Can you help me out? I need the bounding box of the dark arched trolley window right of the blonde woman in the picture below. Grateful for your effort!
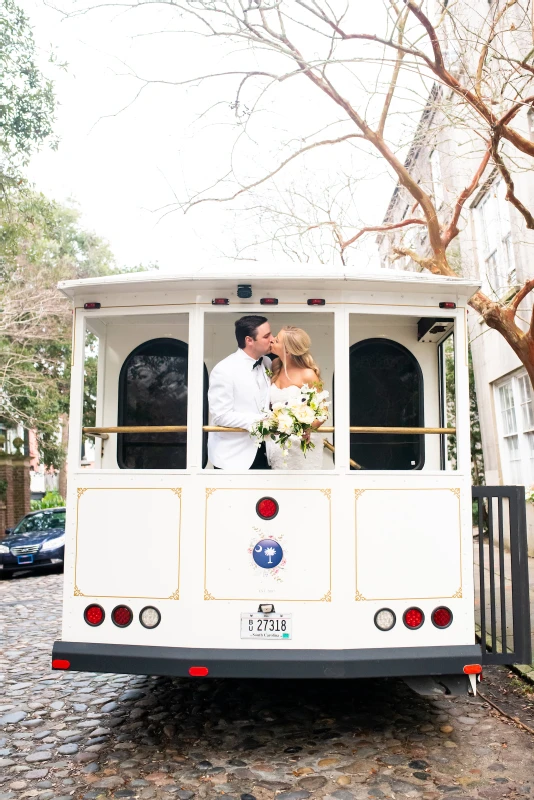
[350,338,425,470]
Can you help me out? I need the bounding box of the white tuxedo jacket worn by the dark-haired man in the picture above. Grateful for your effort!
[208,349,271,470]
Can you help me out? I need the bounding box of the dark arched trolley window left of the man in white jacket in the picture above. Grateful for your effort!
[117,338,208,469]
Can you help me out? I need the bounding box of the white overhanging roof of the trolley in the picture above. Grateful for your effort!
[58,261,480,298]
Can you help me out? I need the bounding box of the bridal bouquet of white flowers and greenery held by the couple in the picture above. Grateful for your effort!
[250,384,330,455]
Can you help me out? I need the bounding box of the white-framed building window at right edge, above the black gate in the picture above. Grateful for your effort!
[497,372,534,486]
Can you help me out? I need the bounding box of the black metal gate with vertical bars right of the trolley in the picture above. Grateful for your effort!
[473,486,532,664]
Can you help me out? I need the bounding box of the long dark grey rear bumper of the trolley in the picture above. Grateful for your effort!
[52,641,482,678]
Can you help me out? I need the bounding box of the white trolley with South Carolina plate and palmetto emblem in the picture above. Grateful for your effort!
[53,263,528,691]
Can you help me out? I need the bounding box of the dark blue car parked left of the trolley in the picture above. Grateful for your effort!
[0,508,66,577]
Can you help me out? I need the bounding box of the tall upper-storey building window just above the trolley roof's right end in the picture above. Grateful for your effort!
[475,178,516,297]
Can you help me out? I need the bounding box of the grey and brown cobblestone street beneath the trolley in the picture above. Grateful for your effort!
[0,575,534,800]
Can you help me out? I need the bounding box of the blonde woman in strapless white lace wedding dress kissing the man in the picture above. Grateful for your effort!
[266,325,323,469]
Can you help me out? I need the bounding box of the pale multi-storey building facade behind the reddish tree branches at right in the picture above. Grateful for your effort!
[377,0,534,555]
